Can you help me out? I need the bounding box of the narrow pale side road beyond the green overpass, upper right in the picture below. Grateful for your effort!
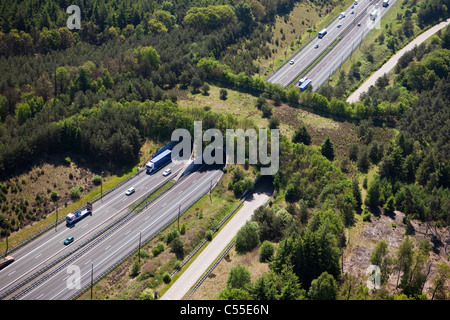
[347,19,450,102]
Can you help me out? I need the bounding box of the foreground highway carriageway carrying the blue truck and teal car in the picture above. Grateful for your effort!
[0,159,182,295]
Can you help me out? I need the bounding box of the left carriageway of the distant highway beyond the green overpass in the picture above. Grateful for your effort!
[266,0,374,86]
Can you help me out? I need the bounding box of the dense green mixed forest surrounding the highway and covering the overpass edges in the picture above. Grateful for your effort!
[0,0,450,299]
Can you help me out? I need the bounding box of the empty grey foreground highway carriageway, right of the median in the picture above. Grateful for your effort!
[16,166,223,300]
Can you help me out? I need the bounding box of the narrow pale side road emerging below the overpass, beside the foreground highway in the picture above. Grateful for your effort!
[161,182,273,300]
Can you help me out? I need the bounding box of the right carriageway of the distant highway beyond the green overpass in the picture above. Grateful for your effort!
[305,0,395,91]
